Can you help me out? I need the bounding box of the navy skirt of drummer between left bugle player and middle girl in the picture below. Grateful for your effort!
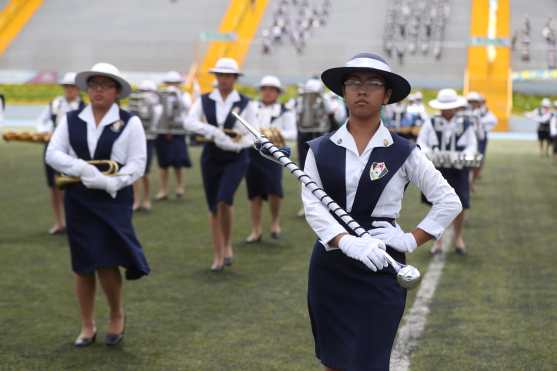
[155,134,192,169]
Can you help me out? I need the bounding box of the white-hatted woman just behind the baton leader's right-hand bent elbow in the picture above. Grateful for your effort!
[417,89,478,255]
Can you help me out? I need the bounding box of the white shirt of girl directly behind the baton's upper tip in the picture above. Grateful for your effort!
[250,101,298,140]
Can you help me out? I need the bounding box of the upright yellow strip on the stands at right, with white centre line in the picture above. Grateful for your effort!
[464,0,512,131]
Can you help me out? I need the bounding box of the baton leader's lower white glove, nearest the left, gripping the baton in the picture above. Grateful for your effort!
[338,235,388,272]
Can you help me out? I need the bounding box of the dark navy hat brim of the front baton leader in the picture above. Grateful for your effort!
[321,67,411,104]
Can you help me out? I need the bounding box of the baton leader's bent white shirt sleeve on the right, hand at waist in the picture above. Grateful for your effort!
[403,148,462,239]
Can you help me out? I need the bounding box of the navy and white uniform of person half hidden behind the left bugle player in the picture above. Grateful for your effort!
[36,96,85,188]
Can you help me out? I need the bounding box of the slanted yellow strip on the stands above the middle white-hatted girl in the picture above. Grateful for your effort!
[197,0,268,93]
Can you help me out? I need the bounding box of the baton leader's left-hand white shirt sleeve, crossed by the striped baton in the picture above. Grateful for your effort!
[302,149,347,244]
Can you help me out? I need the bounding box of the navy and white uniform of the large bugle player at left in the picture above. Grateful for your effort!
[46,104,150,279]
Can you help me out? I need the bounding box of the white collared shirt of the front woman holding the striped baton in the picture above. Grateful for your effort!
[302,123,462,245]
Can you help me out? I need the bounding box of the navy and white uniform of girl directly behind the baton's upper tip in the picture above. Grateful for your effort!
[246,102,297,200]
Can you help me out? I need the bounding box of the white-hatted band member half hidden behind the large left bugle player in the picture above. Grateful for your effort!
[37,72,85,235]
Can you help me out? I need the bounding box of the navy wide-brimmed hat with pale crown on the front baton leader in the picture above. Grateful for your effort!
[321,53,411,104]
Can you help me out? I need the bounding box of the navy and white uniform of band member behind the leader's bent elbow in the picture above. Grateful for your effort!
[417,113,478,209]
